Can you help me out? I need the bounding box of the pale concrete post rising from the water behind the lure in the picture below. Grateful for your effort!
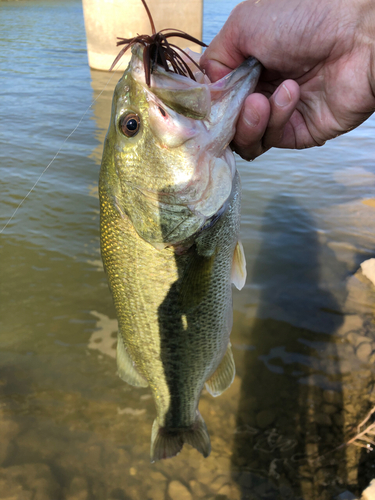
[82,0,203,71]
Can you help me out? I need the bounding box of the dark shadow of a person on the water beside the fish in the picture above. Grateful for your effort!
[232,195,347,500]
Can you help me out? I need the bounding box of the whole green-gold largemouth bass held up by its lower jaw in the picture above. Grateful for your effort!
[99,44,260,461]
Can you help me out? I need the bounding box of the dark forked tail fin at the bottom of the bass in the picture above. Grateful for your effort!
[151,412,211,462]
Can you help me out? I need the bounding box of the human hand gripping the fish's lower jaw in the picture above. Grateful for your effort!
[200,0,375,160]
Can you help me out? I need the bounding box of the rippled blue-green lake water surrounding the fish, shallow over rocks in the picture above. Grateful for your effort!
[0,0,375,500]
